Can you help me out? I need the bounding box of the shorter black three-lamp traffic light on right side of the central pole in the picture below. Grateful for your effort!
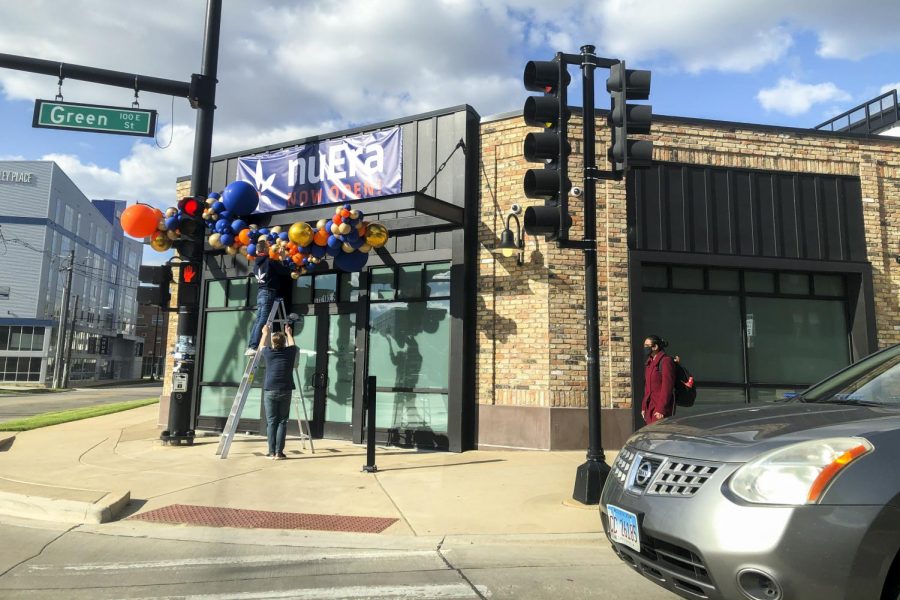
[606,61,653,173]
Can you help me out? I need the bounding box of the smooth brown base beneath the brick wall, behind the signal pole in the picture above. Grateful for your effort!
[477,404,633,450]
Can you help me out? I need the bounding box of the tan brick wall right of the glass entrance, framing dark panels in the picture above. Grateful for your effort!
[477,111,900,436]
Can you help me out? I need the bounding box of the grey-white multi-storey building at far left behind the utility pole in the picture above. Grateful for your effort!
[0,161,143,383]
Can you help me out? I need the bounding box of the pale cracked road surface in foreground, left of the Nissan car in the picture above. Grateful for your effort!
[0,521,675,600]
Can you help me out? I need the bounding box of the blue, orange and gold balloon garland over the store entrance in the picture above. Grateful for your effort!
[119,181,388,279]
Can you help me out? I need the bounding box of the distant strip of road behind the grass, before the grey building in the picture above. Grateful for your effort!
[0,382,162,423]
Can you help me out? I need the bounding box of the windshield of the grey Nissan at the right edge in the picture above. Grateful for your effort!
[797,346,900,408]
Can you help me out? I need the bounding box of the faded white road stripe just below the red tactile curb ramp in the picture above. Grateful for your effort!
[28,550,439,572]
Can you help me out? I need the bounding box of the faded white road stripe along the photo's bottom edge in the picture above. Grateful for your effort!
[125,583,491,600]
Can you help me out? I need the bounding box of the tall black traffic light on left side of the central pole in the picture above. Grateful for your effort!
[523,54,572,241]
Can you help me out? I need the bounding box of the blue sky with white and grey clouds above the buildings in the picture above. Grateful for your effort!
[0,0,900,264]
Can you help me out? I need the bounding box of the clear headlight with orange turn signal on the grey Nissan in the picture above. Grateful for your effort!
[728,437,873,505]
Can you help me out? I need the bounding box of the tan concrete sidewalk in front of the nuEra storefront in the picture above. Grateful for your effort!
[0,405,615,536]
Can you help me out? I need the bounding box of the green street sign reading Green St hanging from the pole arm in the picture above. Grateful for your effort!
[31,100,156,137]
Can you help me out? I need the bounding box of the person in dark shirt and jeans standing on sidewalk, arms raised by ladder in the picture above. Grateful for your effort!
[260,324,298,460]
